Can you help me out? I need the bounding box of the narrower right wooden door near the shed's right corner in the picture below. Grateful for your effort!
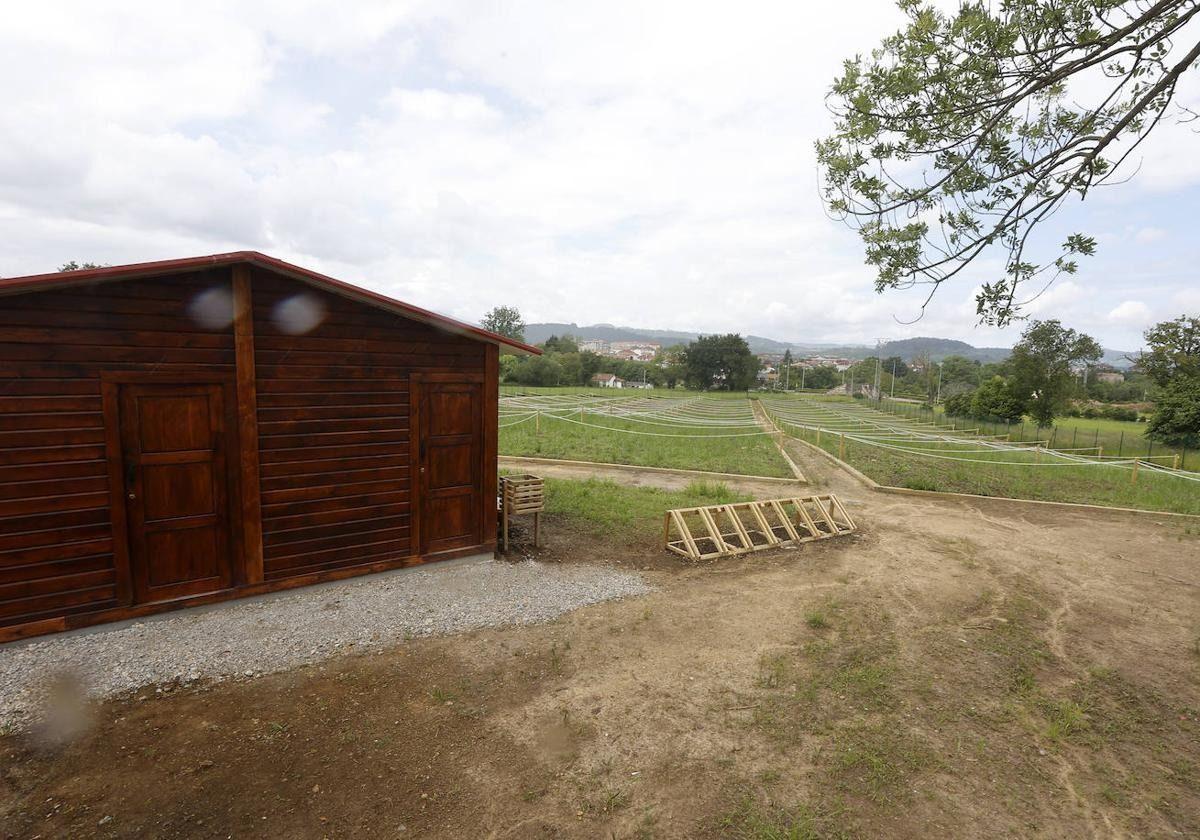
[418,380,484,554]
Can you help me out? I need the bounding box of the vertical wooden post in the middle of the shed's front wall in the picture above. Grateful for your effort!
[233,264,264,584]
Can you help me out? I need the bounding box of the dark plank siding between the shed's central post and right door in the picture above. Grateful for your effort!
[252,271,484,581]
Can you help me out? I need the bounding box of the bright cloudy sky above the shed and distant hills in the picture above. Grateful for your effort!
[0,0,1200,350]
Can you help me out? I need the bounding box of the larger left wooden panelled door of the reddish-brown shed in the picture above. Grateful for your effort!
[120,383,233,604]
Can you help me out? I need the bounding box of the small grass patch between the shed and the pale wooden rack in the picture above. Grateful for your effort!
[546,479,750,539]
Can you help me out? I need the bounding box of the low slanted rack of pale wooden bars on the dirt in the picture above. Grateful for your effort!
[662,493,856,560]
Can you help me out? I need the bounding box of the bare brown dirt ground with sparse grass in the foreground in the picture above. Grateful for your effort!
[0,451,1200,839]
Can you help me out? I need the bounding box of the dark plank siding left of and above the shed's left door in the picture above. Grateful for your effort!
[0,270,234,625]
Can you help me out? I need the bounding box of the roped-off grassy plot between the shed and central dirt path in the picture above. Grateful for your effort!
[500,389,791,478]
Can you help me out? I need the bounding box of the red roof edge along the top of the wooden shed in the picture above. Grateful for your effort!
[0,251,541,355]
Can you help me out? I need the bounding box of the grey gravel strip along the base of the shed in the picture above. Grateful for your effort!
[0,560,650,728]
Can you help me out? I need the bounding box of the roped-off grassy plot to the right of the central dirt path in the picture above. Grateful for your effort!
[773,401,1200,515]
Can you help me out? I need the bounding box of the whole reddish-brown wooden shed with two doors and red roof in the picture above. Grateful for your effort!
[0,252,538,641]
